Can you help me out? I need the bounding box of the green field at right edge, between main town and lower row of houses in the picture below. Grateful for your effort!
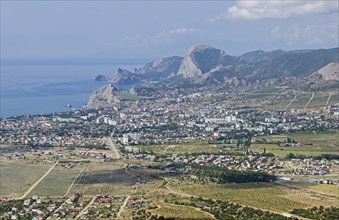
[252,131,339,158]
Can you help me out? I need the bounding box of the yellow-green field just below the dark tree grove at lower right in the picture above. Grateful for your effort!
[181,183,307,212]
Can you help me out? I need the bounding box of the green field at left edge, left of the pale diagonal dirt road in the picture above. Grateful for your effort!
[0,161,52,197]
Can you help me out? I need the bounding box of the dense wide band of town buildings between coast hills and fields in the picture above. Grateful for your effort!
[0,102,339,147]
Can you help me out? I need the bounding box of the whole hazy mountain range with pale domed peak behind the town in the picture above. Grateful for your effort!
[89,45,339,108]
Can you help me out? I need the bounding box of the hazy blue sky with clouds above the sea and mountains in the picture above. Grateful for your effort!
[0,0,339,62]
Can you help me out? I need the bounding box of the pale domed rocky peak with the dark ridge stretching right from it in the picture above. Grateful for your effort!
[176,45,339,86]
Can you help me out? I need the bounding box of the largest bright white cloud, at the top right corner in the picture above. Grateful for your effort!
[208,0,339,22]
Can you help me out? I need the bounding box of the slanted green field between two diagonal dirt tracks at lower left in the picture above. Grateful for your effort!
[29,164,85,196]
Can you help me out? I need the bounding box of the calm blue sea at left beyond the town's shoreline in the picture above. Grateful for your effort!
[0,64,141,117]
